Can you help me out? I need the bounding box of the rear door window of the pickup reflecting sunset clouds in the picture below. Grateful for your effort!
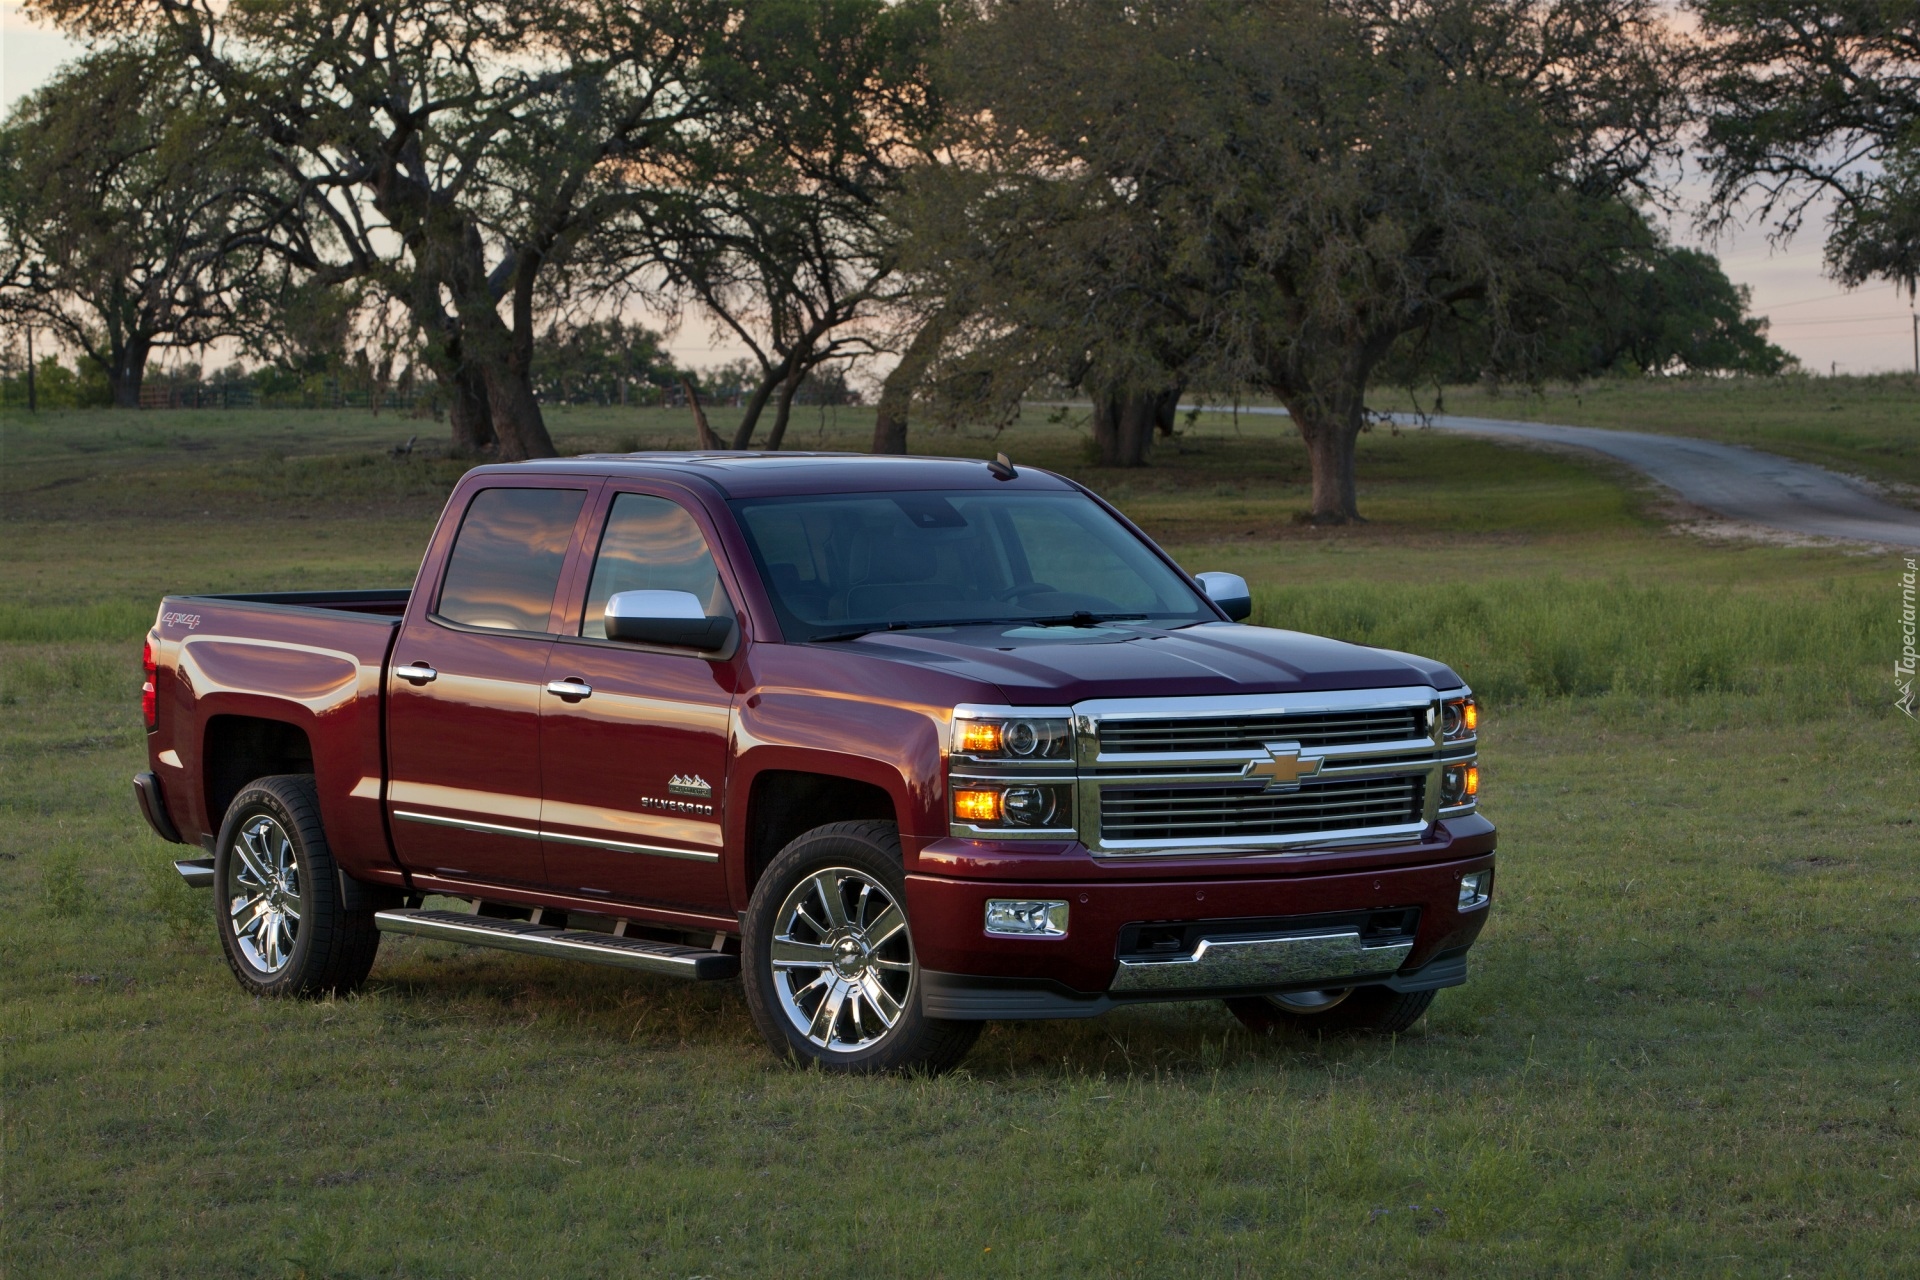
[434,489,588,631]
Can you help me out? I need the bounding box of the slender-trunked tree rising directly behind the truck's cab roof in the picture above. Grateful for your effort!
[605,0,939,449]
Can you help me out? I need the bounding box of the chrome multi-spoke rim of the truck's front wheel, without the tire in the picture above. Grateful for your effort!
[768,867,914,1054]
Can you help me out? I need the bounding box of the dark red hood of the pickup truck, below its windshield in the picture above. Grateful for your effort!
[835,622,1461,706]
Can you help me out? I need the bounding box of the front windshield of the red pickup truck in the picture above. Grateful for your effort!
[733,489,1215,641]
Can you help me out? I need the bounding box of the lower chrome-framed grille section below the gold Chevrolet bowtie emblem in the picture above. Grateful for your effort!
[1100,773,1427,841]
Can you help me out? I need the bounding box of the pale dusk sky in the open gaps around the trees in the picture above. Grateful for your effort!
[0,0,1920,374]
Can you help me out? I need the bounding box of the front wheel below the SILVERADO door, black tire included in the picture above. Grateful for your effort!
[741,821,979,1075]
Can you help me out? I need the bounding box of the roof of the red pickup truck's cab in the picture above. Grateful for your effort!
[480,451,1073,497]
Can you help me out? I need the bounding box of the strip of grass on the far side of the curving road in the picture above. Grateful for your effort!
[1377,374,1920,505]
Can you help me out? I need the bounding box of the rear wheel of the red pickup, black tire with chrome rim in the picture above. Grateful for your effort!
[213,773,380,996]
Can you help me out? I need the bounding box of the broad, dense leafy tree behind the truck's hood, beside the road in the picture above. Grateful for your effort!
[898,0,1676,522]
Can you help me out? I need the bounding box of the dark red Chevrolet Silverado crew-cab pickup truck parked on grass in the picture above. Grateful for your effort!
[134,453,1494,1071]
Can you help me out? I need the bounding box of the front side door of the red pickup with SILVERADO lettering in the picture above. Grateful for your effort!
[540,493,735,912]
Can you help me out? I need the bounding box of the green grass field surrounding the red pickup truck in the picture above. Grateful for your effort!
[0,397,1920,1276]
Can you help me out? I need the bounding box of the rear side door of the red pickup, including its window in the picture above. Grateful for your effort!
[388,476,599,885]
